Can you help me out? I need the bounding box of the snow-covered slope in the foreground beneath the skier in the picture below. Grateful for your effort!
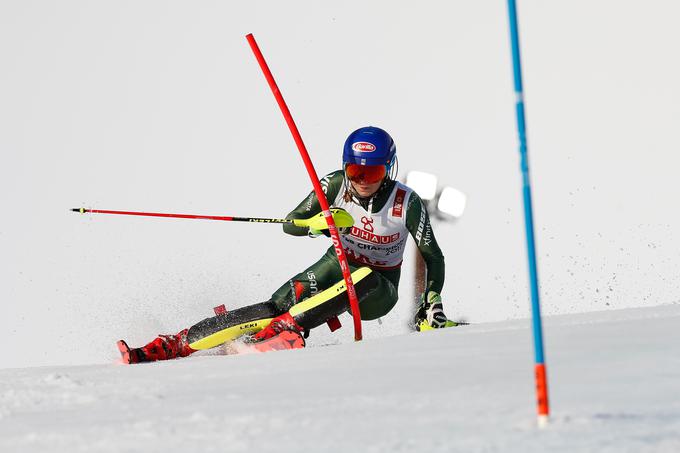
[0,305,680,453]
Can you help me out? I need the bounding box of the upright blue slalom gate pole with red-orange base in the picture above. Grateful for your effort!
[508,0,549,426]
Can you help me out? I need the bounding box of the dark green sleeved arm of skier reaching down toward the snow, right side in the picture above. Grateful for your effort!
[406,192,444,293]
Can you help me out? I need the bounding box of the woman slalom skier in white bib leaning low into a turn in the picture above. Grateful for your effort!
[118,127,456,363]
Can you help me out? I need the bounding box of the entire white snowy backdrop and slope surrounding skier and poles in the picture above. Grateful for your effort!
[0,0,680,452]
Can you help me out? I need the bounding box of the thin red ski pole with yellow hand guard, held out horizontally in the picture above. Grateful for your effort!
[71,208,354,230]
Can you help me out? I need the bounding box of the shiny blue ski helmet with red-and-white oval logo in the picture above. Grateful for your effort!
[342,126,397,167]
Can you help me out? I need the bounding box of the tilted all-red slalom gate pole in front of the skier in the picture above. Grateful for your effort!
[246,33,361,341]
